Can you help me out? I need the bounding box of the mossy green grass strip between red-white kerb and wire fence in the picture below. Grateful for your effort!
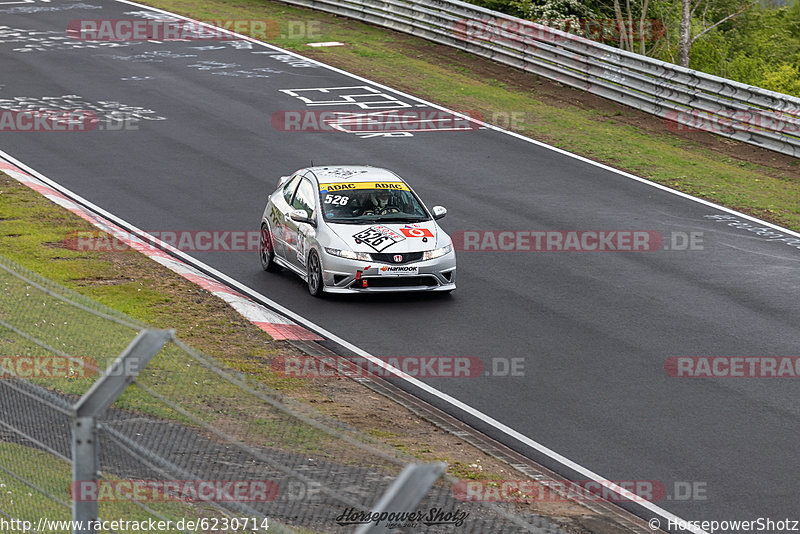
[0,173,300,391]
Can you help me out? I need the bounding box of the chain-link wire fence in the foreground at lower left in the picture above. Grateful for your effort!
[0,258,558,534]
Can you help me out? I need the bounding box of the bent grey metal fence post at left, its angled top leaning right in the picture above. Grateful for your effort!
[72,330,175,534]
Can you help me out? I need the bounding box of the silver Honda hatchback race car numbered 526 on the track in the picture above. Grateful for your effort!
[259,165,456,296]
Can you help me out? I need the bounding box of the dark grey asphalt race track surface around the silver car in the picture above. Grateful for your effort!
[0,0,800,520]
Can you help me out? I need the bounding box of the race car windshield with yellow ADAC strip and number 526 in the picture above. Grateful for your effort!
[319,182,430,224]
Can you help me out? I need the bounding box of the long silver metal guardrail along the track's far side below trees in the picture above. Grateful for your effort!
[281,0,800,157]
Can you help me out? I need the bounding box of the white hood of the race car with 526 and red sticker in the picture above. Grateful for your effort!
[328,220,442,253]
